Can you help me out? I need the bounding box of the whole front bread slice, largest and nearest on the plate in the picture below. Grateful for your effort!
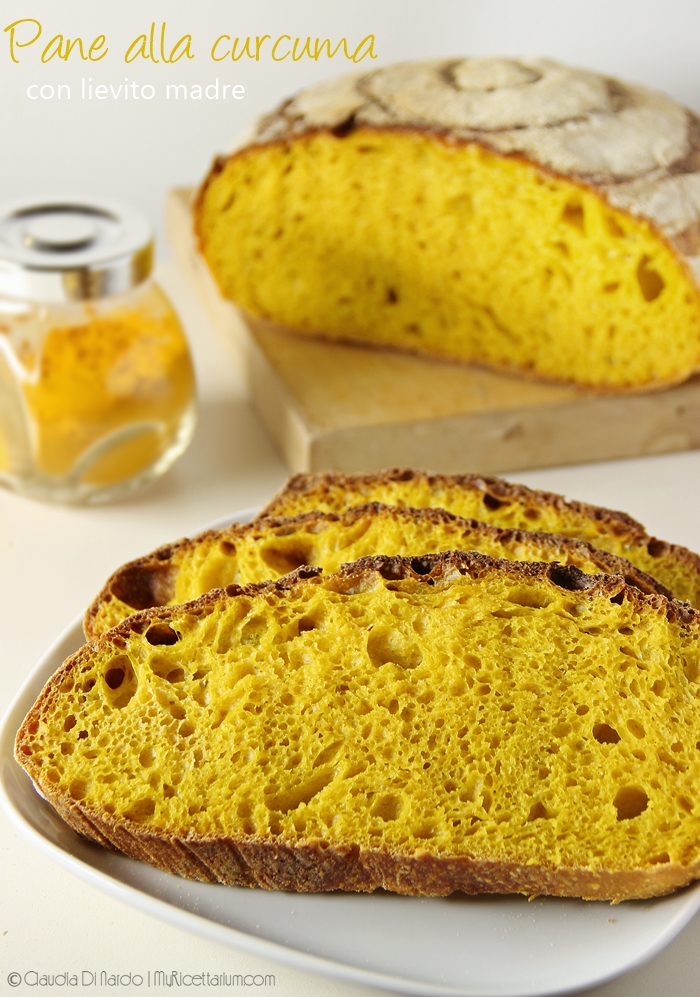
[16,552,700,900]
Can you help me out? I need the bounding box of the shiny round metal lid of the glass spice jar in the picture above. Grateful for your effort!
[0,197,153,302]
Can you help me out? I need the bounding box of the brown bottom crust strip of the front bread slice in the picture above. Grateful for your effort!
[15,794,700,903]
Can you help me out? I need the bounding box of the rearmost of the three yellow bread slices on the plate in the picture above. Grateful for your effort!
[261,468,700,608]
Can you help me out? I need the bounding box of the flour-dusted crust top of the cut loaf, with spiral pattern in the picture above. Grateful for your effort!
[242,56,700,275]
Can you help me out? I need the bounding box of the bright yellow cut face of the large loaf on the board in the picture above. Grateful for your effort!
[197,134,700,389]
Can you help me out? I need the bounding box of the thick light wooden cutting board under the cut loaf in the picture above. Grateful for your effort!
[168,189,700,473]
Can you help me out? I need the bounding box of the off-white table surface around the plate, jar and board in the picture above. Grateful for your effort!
[0,264,700,997]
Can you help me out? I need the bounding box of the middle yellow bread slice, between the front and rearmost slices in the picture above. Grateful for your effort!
[84,502,671,640]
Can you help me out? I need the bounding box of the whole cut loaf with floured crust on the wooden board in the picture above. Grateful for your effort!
[195,57,700,390]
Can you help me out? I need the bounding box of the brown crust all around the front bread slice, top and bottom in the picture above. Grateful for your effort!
[15,551,700,902]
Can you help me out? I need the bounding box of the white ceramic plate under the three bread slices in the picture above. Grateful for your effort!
[0,512,700,997]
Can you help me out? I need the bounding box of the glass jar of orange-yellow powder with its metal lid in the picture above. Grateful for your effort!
[0,199,196,502]
